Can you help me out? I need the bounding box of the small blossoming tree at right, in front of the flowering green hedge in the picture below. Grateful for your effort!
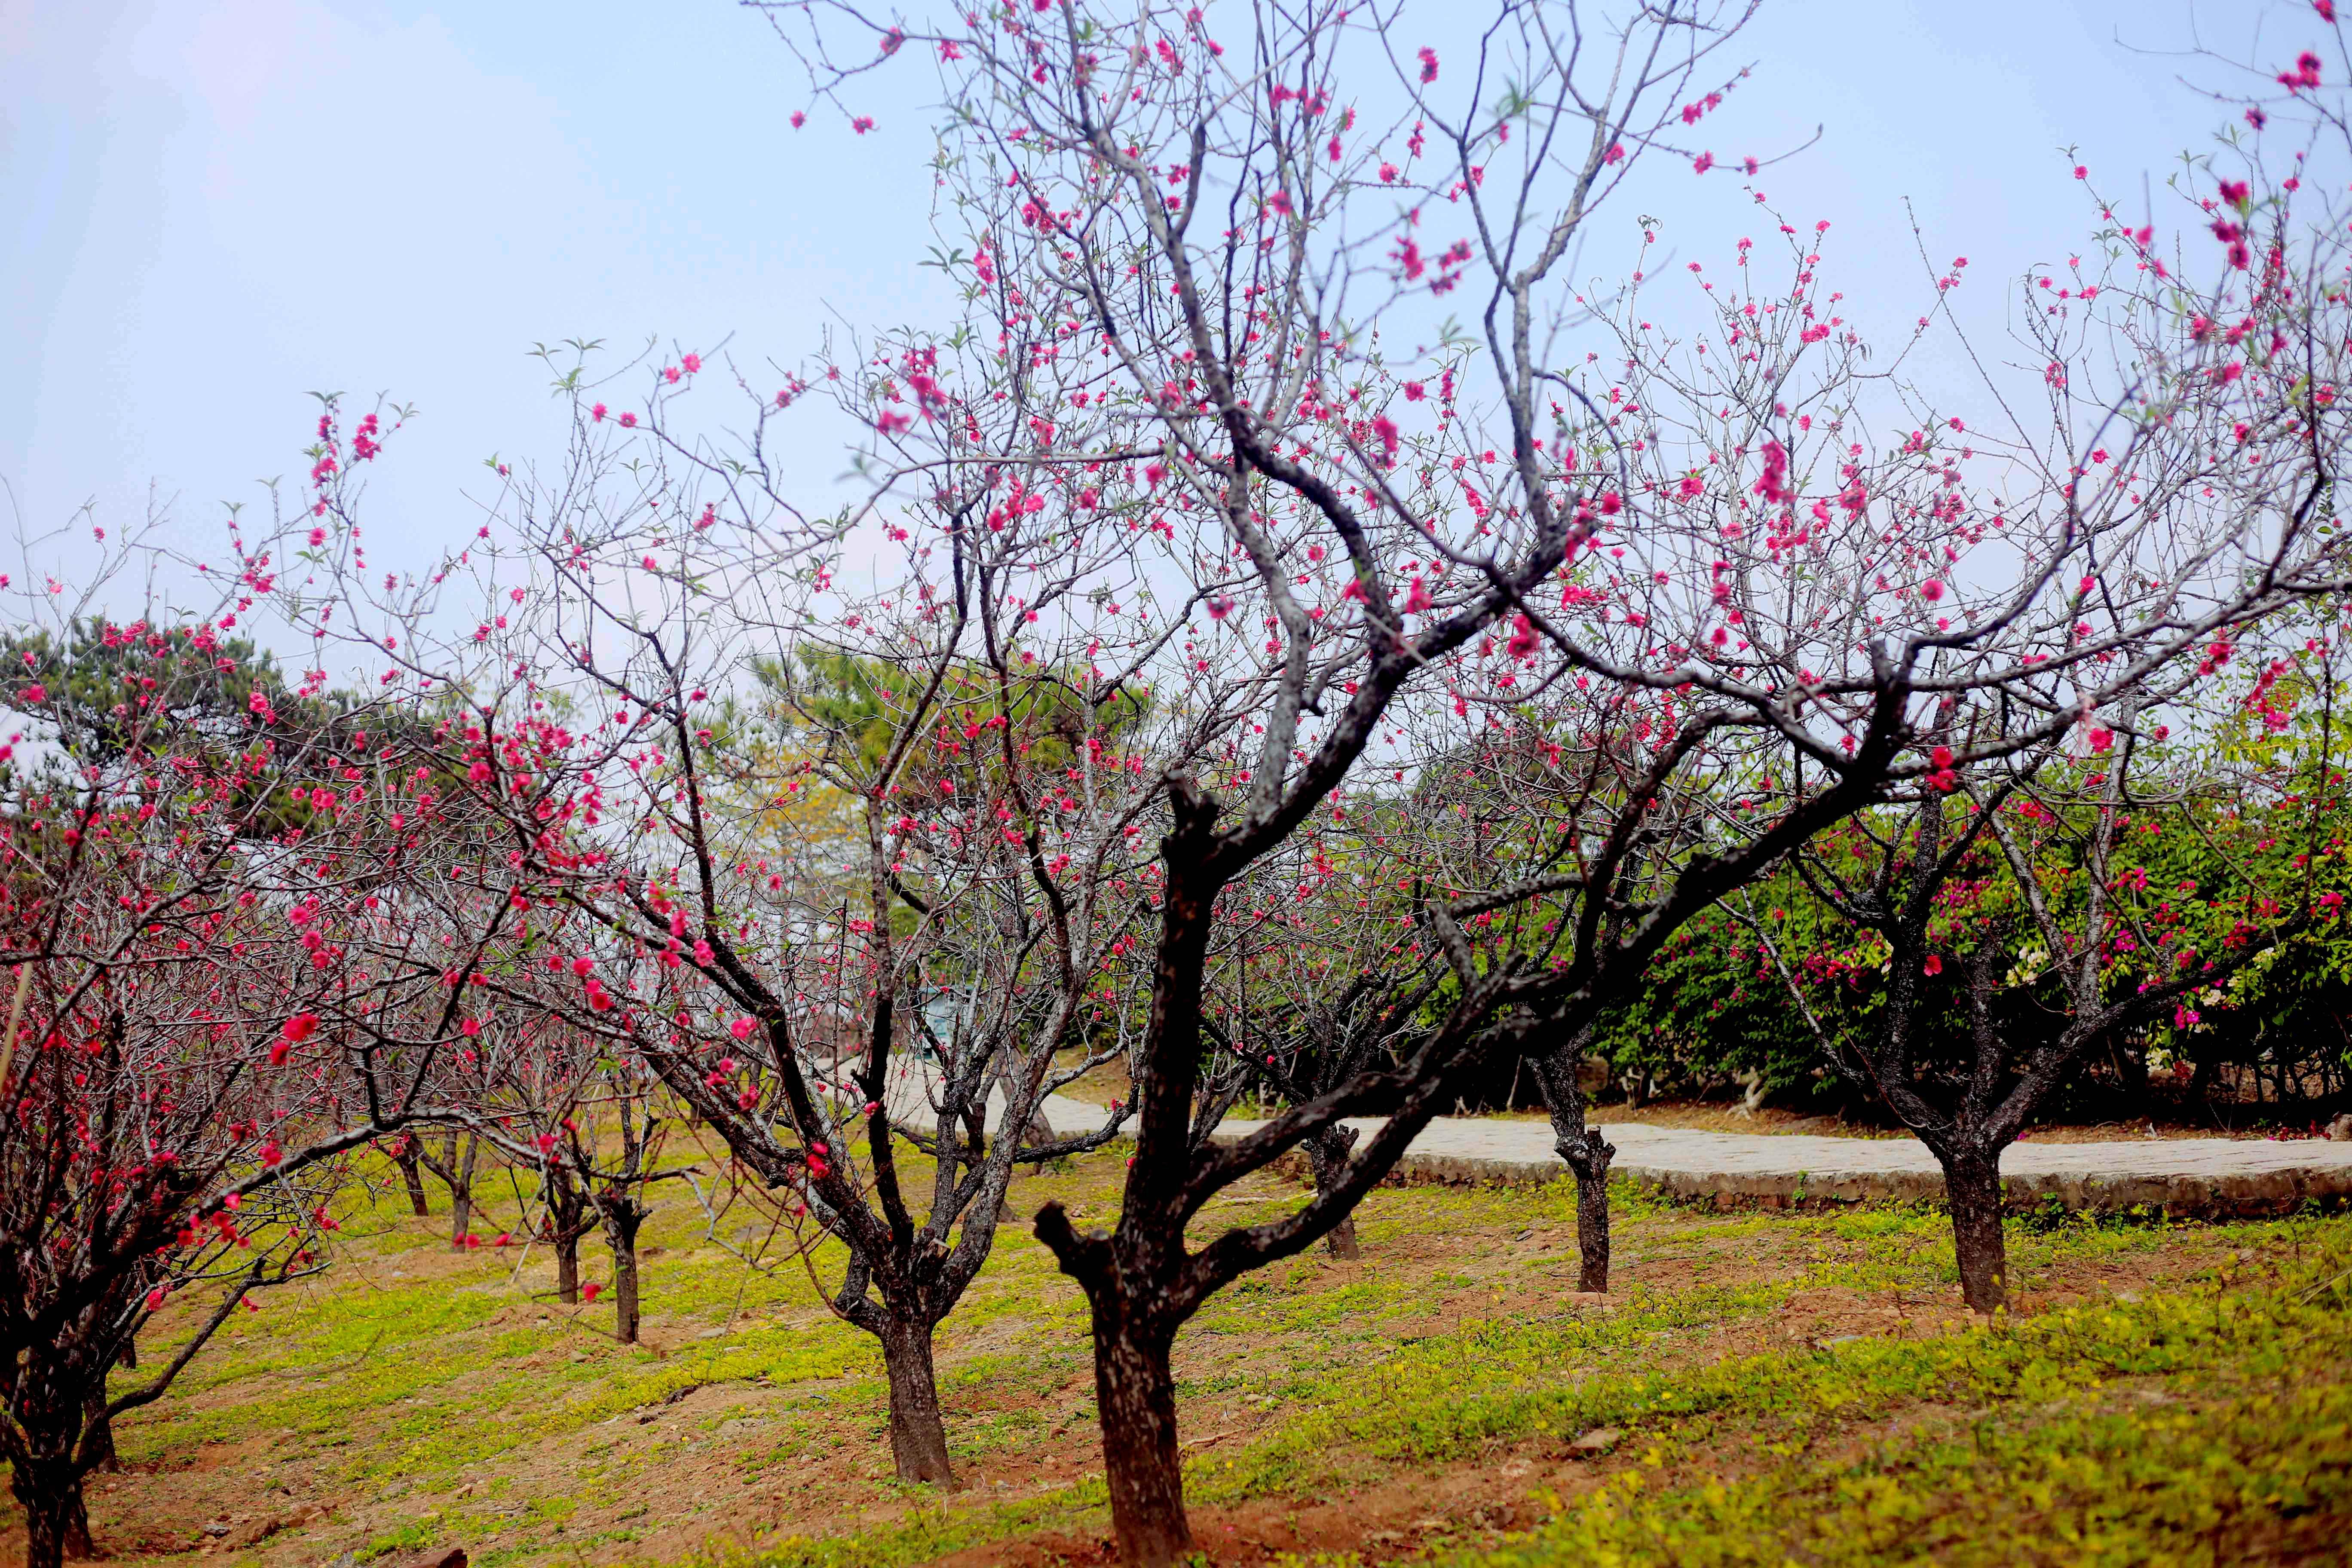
[1740,628,2345,1312]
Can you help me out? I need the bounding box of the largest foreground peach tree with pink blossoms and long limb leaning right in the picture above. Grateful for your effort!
[720,2,2343,1563]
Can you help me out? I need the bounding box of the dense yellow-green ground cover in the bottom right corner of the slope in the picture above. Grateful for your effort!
[1444,1253,2352,1568]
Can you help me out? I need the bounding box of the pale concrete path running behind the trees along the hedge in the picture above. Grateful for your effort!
[891,1077,2352,1216]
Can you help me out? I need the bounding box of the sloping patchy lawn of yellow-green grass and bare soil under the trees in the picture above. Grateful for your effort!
[0,1154,2352,1568]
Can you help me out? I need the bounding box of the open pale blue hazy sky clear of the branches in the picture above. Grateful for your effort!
[0,0,2276,588]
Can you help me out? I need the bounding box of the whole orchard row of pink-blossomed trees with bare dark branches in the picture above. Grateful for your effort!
[14,0,2352,1566]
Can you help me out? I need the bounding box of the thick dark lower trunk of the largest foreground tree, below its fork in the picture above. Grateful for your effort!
[1093,1283,1192,1568]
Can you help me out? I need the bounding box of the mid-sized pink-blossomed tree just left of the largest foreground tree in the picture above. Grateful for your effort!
[287,301,1192,1481]
